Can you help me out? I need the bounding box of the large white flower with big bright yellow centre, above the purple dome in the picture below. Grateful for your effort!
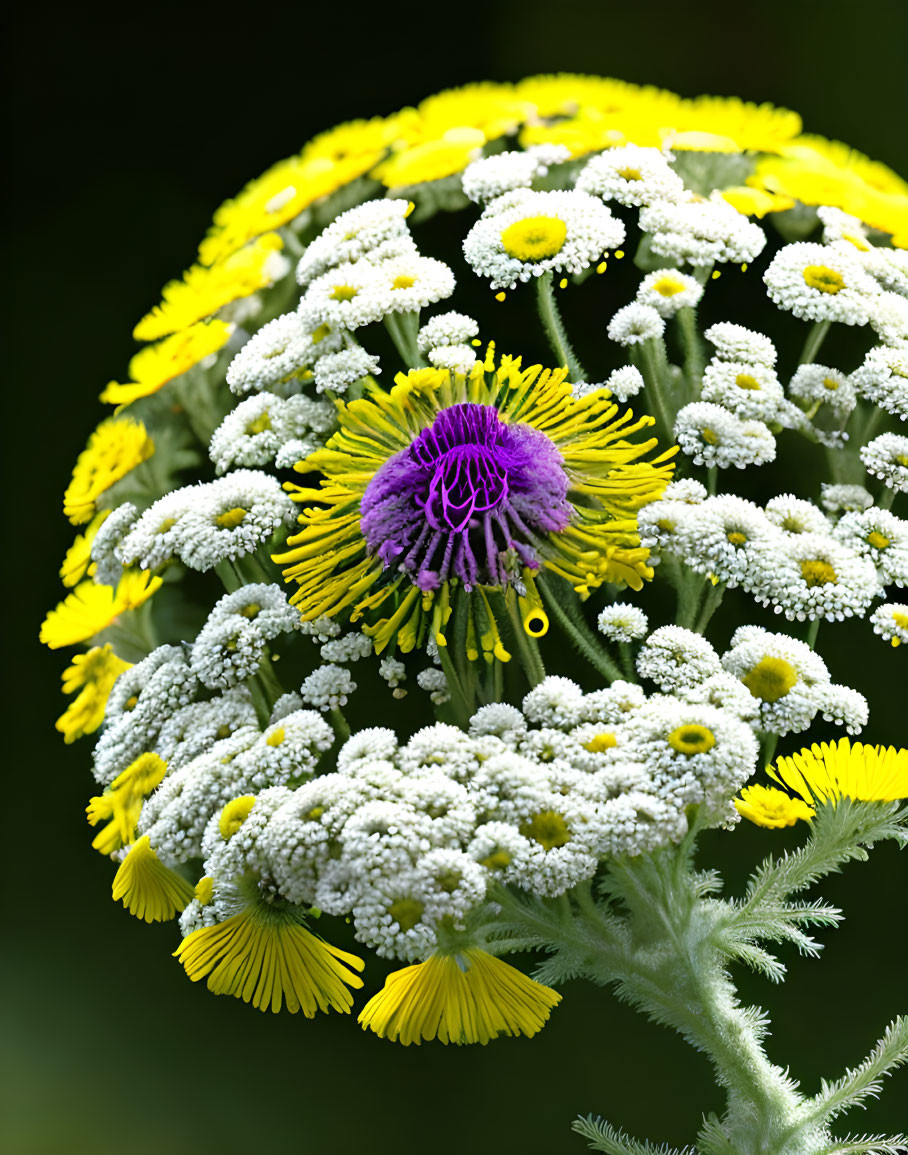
[463,189,625,289]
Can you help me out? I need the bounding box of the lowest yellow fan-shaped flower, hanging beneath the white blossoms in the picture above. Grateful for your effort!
[359,949,561,1046]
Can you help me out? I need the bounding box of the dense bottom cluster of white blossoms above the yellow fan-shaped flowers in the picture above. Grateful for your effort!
[176,677,757,960]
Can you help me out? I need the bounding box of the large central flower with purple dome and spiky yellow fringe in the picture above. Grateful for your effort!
[275,348,673,661]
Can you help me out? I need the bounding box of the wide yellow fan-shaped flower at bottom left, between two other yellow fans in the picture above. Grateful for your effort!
[173,906,363,1019]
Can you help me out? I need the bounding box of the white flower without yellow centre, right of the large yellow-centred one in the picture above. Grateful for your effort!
[640,193,766,267]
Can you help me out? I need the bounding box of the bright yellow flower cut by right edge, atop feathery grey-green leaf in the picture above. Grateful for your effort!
[767,738,908,806]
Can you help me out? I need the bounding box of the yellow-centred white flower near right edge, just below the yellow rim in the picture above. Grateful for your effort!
[764,241,879,325]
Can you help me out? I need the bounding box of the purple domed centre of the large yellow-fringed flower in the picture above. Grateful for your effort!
[362,404,572,589]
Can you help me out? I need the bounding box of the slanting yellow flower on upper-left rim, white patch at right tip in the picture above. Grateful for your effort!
[133,232,286,341]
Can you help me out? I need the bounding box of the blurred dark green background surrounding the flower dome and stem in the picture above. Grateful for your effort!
[7,0,908,1155]
